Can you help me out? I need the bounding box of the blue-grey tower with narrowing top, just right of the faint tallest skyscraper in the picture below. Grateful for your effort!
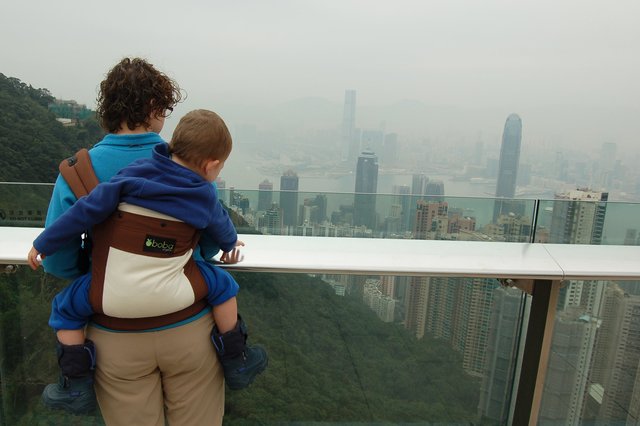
[353,151,378,229]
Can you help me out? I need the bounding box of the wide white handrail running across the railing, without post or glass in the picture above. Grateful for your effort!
[5,227,640,281]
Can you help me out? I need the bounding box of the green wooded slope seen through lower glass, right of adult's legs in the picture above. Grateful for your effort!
[225,273,480,424]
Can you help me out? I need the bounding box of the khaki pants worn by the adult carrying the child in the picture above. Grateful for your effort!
[87,314,224,426]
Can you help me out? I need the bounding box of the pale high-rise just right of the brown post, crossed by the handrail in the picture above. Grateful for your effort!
[540,189,612,425]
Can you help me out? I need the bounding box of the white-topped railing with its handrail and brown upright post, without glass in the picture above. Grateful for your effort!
[0,227,640,425]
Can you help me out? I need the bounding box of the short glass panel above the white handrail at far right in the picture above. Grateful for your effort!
[536,198,640,245]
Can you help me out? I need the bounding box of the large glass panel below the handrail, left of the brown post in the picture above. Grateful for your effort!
[0,267,526,425]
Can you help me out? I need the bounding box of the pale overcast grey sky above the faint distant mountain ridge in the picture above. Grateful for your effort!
[0,0,640,151]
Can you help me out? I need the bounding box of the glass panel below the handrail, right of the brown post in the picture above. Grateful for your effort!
[539,281,640,425]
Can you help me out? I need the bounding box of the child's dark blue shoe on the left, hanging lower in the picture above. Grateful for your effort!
[42,340,96,414]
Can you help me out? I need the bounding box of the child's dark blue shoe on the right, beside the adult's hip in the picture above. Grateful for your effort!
[211,315,268,390]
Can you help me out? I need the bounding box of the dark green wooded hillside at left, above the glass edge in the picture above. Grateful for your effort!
[0,73,102,182]
